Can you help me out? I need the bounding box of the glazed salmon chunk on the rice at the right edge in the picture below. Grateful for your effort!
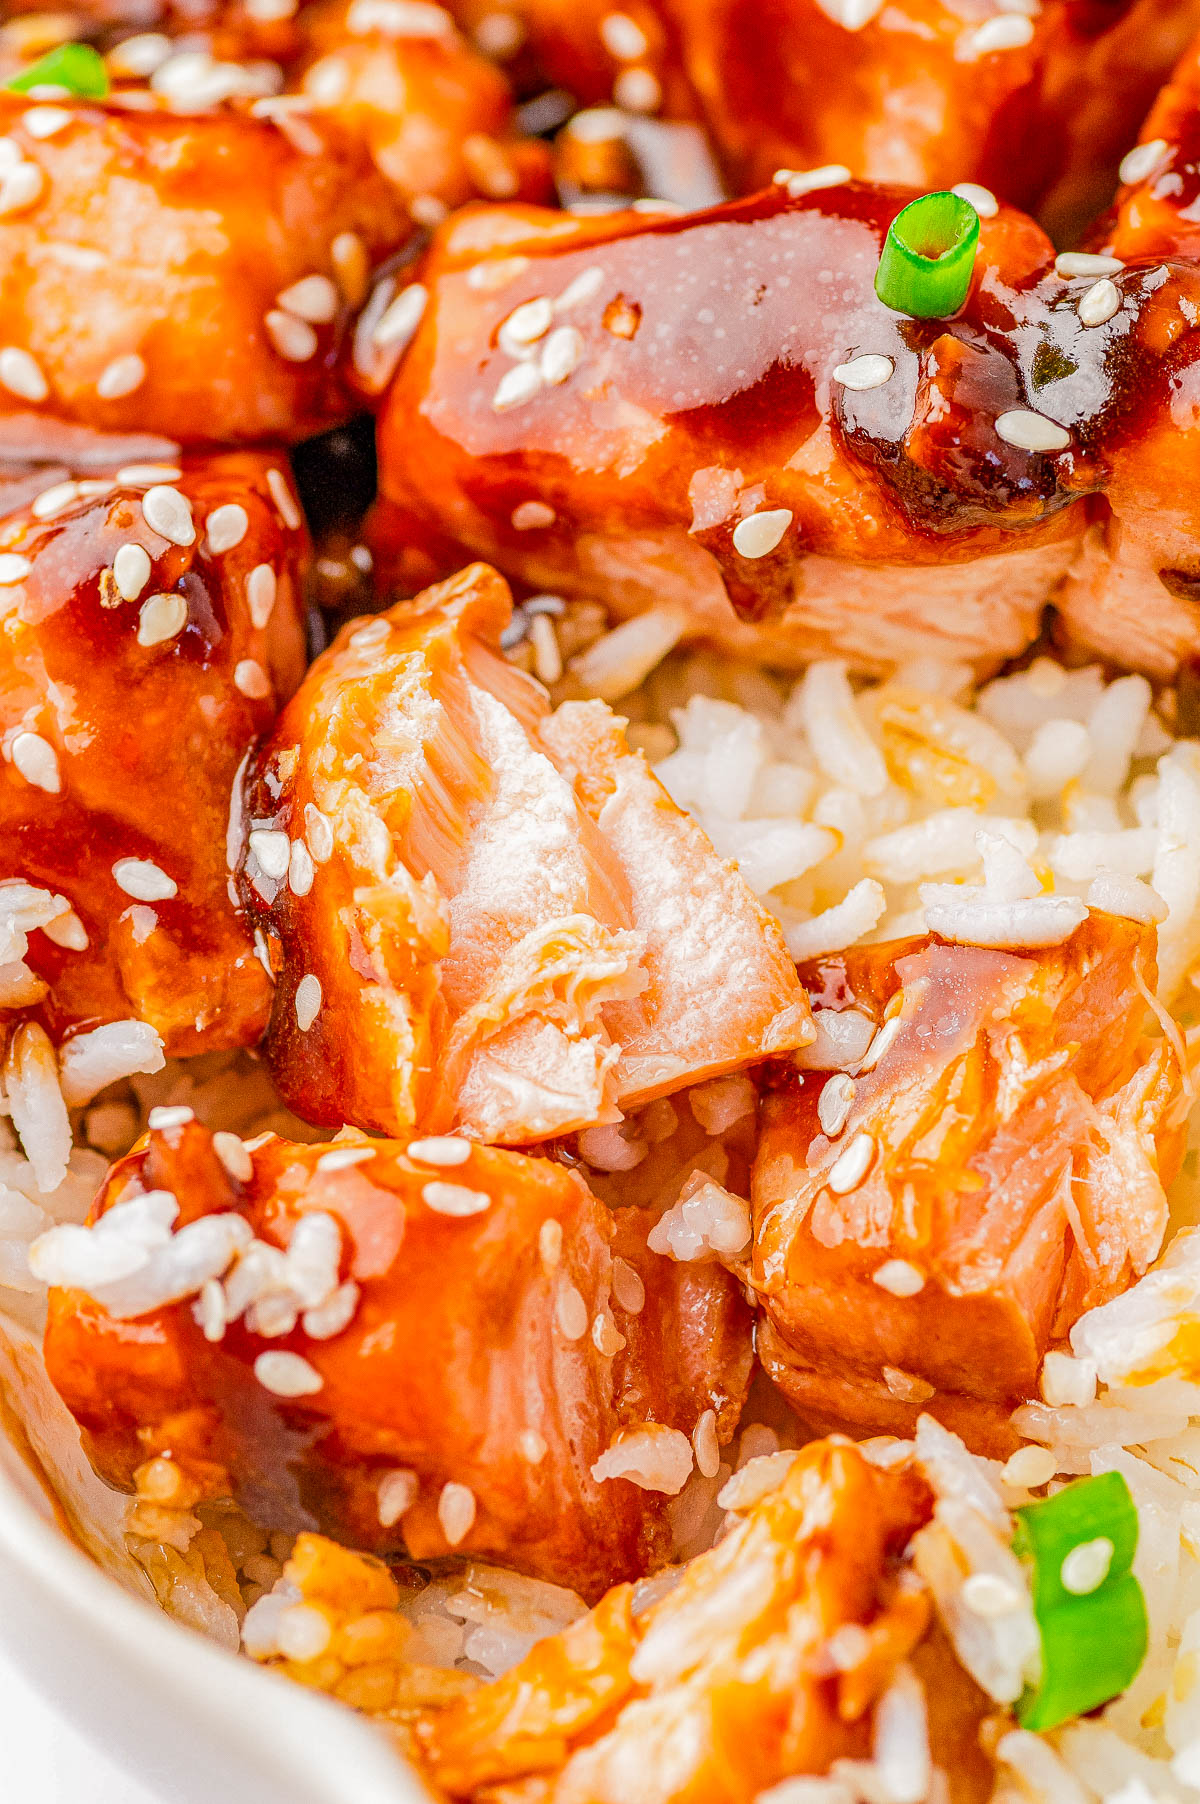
[745,911,1186,1452]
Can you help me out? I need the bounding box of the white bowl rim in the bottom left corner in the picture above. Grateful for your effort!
[0,1321,431,1804]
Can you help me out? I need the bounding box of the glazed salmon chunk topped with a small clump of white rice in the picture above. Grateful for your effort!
[44,1122,751,1598]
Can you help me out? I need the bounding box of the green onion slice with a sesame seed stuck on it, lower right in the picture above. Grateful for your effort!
[1012,1472,1148,1730]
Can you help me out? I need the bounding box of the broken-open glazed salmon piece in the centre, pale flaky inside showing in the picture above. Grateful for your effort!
[242,566,812,1142]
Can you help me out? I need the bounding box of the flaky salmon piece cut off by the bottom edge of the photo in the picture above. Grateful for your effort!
[415,1440,985,1804]
